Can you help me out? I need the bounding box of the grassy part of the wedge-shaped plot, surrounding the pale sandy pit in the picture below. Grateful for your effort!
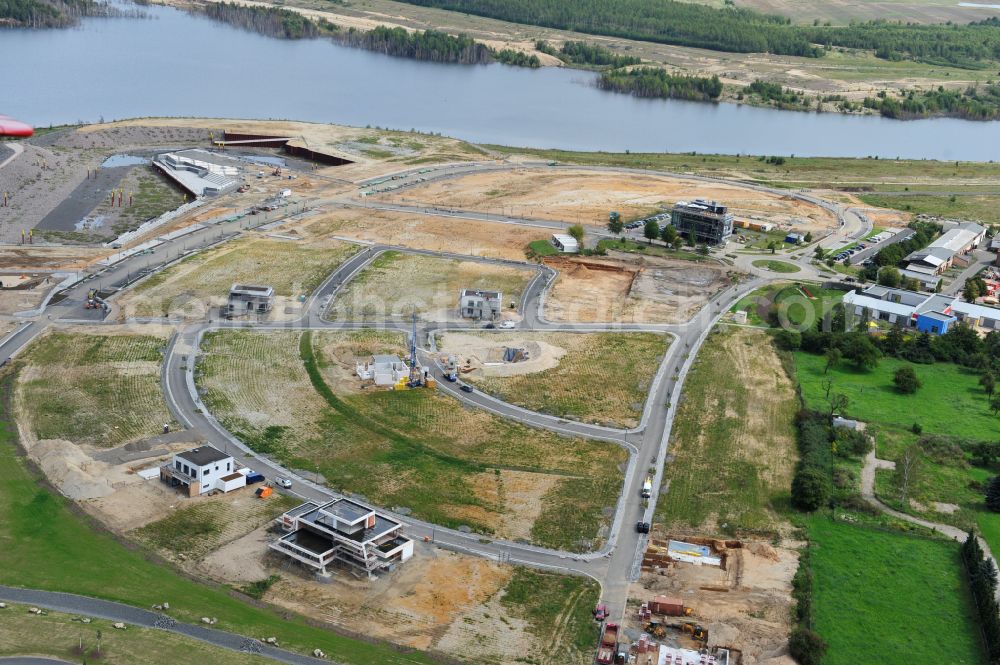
[440,333,670,427]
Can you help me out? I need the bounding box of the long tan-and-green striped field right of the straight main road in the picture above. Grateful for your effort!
[656,328,798,534]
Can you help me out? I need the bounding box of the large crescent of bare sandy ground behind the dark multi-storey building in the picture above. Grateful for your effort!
[379,169,837,231]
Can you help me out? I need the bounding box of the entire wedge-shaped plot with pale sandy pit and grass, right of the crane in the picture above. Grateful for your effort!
[438,333,671,427]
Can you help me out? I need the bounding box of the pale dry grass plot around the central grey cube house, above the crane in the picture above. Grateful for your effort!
[328,251,535,321]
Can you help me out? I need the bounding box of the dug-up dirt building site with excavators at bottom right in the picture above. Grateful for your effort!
[626,534,798,665]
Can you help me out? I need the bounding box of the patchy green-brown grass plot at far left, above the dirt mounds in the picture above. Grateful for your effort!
[17,332,172,447]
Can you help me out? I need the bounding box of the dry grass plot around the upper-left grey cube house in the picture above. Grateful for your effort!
[118,236,357,319]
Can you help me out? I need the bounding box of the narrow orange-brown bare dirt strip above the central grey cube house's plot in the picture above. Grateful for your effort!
[297,208,548,260]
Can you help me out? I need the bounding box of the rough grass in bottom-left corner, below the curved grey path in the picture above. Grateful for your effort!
[0,605,264,665]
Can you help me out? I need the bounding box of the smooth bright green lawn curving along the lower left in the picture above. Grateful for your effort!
[0,378,442,665]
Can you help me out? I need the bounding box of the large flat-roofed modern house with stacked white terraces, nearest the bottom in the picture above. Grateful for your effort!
[268,499,413,577]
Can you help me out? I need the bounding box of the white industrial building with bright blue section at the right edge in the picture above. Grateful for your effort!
[844,286,1000,335]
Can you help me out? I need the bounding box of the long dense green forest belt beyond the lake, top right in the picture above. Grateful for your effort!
[394,0,1000,68]
